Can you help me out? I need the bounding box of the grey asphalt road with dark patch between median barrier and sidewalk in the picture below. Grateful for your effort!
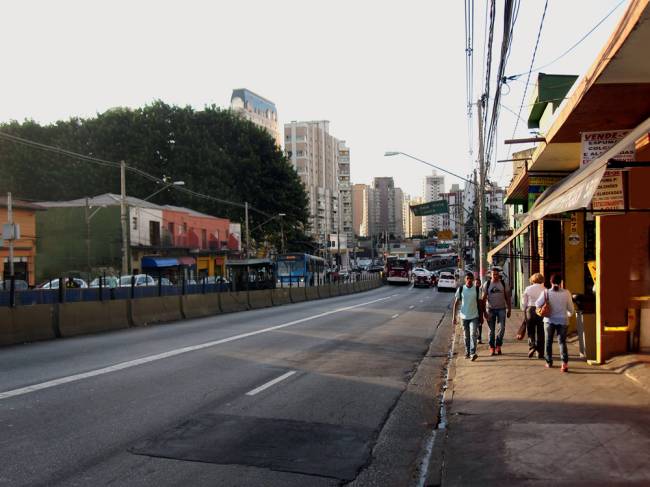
[0,286,451,486]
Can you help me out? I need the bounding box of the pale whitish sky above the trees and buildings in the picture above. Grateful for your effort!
[0,0,629,196]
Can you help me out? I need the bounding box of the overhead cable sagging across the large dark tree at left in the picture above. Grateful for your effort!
[0,132,271,218]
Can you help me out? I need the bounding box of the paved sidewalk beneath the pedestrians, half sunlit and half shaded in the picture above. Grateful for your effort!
[442,311,650,486]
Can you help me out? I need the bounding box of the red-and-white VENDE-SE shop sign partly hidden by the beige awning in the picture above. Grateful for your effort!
[582,130,635,210]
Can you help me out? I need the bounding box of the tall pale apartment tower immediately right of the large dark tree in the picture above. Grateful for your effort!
[284,120,342,244]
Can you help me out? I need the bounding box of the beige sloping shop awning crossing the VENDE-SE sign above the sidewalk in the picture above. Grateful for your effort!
[487,118,650,262]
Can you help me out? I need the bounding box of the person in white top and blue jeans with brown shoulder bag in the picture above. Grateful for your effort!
[535,274,574,372]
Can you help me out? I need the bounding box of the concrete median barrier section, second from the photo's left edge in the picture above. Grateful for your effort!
[59,299,129,337]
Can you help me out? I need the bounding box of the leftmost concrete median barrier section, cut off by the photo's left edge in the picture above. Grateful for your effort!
[0,304,56,346]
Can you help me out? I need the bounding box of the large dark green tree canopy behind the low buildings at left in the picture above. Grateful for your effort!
[0,101,309,248]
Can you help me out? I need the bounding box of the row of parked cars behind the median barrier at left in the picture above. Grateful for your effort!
[0,274,228,291]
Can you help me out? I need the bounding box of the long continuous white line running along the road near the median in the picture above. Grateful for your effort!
[0,294,396,400]
